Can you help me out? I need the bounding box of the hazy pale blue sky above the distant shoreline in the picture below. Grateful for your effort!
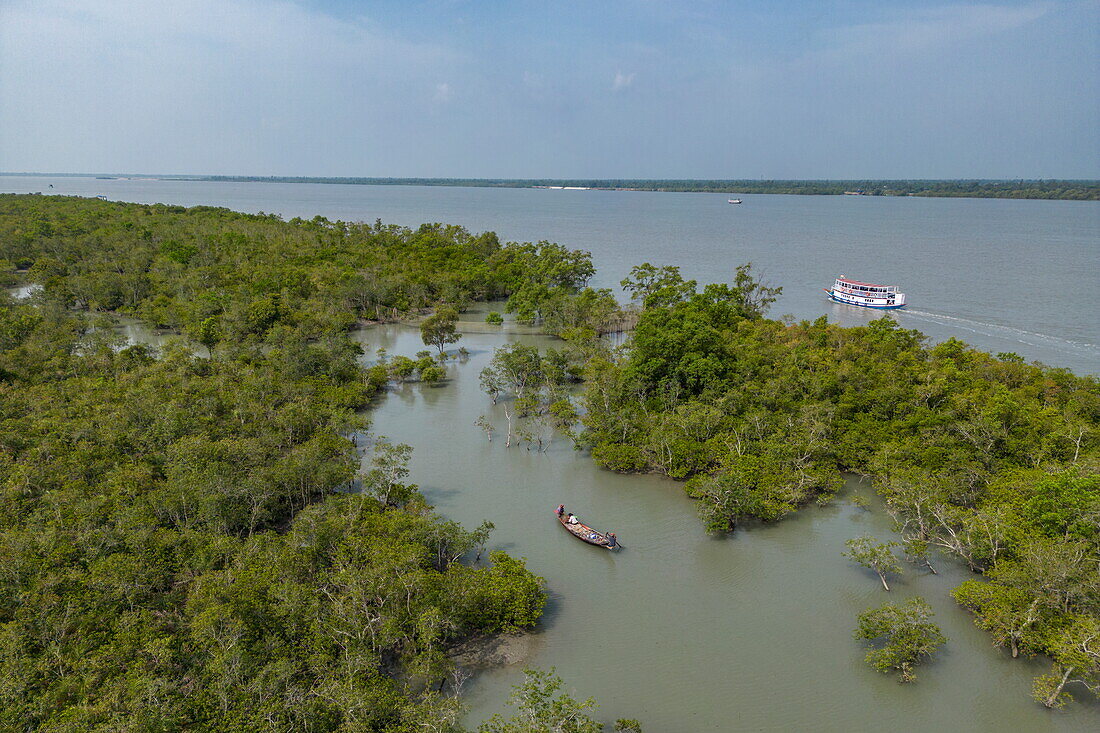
[0,0,1100,178]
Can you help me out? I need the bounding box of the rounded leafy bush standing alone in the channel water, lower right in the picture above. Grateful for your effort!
[855,598,947,682]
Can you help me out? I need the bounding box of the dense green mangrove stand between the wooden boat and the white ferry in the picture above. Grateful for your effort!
[583,260,1100,704]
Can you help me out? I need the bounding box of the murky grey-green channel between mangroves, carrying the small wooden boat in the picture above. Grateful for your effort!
[358,314,1100,733]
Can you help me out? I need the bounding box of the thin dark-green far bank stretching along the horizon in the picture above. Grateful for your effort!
[0,173,1100,201]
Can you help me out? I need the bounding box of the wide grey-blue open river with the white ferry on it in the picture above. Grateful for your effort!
[0,176,1100,373]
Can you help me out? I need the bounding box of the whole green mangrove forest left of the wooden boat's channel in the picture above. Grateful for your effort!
[0,192,567,731]
